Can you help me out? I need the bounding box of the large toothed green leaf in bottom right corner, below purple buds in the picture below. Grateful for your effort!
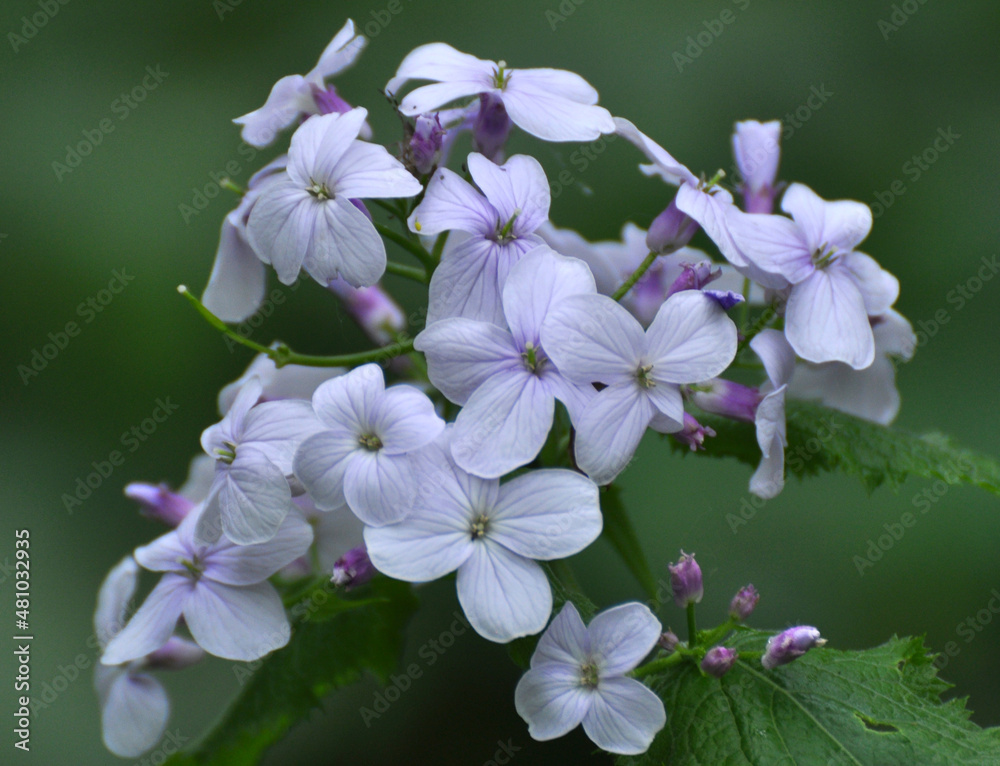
[617,629,1000,766]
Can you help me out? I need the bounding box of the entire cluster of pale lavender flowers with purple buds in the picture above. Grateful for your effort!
[98,22,914,755]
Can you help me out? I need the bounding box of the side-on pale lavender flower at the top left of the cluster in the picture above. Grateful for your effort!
[233,19,368,147]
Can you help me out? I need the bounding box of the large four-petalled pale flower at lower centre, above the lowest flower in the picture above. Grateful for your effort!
[365,432,600,643]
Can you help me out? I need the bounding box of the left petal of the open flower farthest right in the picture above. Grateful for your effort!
[726,207,816,284]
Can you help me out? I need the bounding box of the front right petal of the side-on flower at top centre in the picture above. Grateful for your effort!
[502,82,615,141]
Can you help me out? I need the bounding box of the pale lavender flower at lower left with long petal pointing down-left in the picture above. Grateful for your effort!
[101,508,312,665]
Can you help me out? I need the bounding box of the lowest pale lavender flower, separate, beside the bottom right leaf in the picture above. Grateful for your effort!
[514,602,667,755]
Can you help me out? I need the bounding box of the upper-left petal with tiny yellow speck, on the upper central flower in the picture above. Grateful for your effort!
[407,168,500,237]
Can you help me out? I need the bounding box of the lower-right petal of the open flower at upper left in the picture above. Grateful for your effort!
[302,196,386,287]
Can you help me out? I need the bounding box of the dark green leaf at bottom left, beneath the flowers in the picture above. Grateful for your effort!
[167,577,416,766]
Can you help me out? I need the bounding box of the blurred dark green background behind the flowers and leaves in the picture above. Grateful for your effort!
[0,0,1000,765]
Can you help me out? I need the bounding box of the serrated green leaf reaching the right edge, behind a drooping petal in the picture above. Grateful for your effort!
[671,401,1000,494]
